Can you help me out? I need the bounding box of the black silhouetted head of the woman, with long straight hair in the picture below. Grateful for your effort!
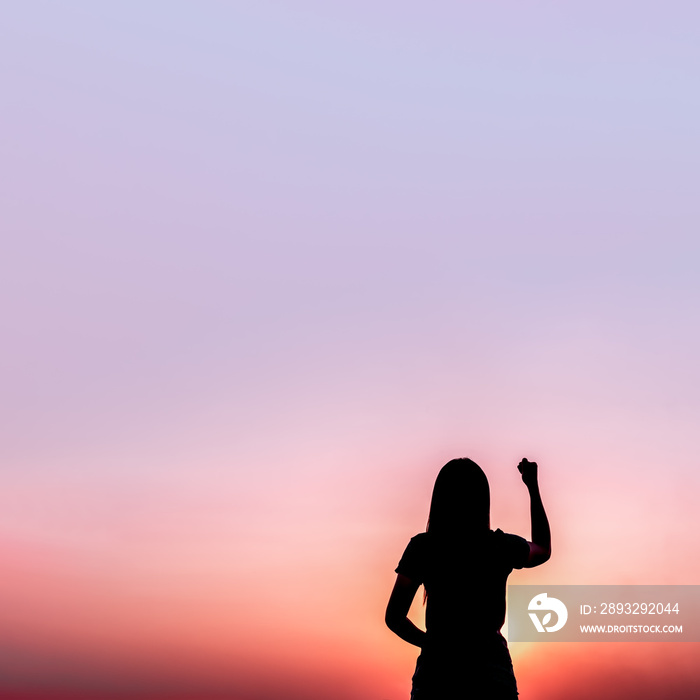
[427,457,491,536]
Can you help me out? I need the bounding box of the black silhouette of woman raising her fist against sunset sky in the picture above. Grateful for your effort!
[386,459,551,700]
